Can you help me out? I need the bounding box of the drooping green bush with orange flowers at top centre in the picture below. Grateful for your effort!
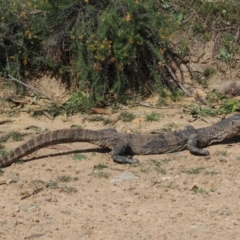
[46,0,178,102]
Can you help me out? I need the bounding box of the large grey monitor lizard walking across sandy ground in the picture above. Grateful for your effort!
[0,114,240,168]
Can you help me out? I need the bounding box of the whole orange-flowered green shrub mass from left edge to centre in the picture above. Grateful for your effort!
[0,0,176,102]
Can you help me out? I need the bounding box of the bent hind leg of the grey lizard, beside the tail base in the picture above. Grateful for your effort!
[111,141,139,164]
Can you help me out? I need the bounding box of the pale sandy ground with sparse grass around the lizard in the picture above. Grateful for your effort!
[0,107,240,240]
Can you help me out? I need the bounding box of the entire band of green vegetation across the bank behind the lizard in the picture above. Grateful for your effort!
[0,0,240,111]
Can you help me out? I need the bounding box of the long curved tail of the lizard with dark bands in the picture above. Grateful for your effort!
[0,129,110,168]
